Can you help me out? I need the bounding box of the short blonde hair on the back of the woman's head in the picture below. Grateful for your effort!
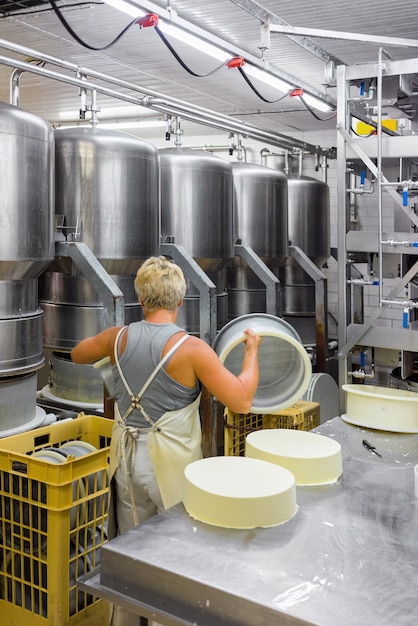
[134,256,186,312]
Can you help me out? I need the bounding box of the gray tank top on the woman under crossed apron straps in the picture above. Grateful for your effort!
[112,320,201,428]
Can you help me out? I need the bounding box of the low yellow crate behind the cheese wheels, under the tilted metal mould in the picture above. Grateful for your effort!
[224,400,320,456]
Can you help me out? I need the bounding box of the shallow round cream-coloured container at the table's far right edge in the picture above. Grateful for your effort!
[341,385,418,433]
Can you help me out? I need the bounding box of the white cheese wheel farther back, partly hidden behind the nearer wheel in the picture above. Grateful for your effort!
[245,428,343,485]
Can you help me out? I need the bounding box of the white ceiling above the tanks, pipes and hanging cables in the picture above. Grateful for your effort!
[0,0,418,145]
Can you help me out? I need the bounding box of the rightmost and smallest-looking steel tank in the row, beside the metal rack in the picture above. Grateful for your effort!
[279,176,331,344]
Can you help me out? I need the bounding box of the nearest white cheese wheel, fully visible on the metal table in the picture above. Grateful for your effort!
[183,456,297,528]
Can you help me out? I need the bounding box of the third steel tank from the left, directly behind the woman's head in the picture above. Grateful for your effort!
[160,148,233,333]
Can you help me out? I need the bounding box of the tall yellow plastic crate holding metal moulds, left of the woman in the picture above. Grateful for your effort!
[0,413,113,626]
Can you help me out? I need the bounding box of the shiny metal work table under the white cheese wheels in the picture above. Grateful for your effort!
[81,417,418,626]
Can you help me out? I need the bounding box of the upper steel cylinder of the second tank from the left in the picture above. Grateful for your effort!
[55,128,159,275]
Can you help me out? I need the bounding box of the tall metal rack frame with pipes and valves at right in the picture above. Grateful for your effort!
[337,48,418,412]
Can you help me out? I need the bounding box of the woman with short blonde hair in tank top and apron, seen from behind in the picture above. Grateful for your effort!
[71,256,261,536]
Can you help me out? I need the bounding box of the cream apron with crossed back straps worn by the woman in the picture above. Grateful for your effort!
[109,327,202,538]
